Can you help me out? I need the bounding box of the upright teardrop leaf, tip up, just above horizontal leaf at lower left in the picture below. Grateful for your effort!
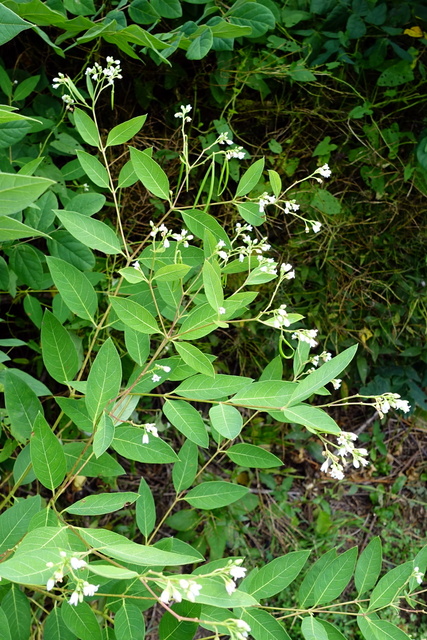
[30,413,67,491]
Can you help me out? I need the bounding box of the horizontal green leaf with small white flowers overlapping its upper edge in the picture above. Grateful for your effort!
[111,427,178,464]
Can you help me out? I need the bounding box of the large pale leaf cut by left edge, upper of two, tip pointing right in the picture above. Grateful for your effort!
[0,171,55,216]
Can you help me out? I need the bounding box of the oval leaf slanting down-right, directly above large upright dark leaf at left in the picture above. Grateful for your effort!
[46,256,98,322]
